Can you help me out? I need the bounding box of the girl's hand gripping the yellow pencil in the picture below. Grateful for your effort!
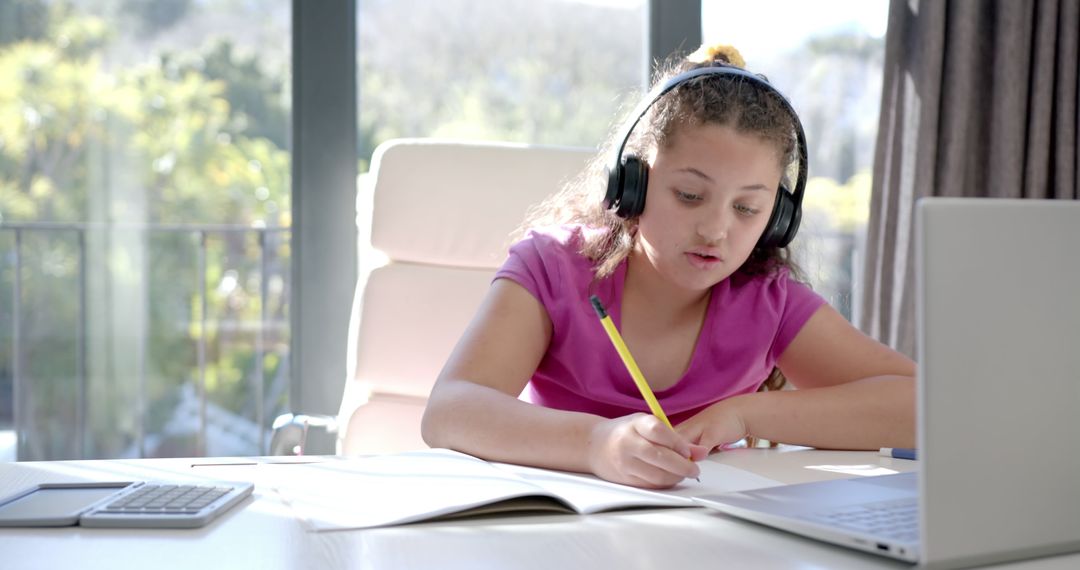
[588,413,707,489]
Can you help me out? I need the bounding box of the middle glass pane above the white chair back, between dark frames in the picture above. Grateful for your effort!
[357,0,645,163]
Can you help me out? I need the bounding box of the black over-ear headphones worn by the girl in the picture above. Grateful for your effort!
[604,65,807,247]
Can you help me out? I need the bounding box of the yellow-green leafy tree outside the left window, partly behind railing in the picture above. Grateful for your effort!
[0,4,289,459]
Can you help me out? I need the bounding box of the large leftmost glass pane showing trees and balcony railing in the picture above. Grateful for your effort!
[0,0,292,460]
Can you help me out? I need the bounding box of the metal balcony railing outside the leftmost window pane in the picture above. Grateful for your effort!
[0,222,291,460]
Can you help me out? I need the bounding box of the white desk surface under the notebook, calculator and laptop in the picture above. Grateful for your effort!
[0,448,1080,570]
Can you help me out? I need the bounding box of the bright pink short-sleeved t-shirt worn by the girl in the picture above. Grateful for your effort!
[495,227,825,423]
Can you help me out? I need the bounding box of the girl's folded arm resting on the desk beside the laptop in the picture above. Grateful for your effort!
[678,306,915,449]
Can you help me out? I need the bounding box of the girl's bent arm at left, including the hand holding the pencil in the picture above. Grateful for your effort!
[421,280,704,487]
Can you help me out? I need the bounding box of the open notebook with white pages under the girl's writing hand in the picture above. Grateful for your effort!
[259,449,779,531]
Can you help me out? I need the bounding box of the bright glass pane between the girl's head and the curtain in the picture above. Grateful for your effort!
[702,0,889,318]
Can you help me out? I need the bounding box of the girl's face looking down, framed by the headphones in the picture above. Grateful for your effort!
[633,124,781,291]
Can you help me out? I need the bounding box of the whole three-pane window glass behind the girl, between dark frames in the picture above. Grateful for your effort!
[0,0,886,460]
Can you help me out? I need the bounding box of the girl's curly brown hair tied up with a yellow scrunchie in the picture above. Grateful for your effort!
[515,45,805,431]
